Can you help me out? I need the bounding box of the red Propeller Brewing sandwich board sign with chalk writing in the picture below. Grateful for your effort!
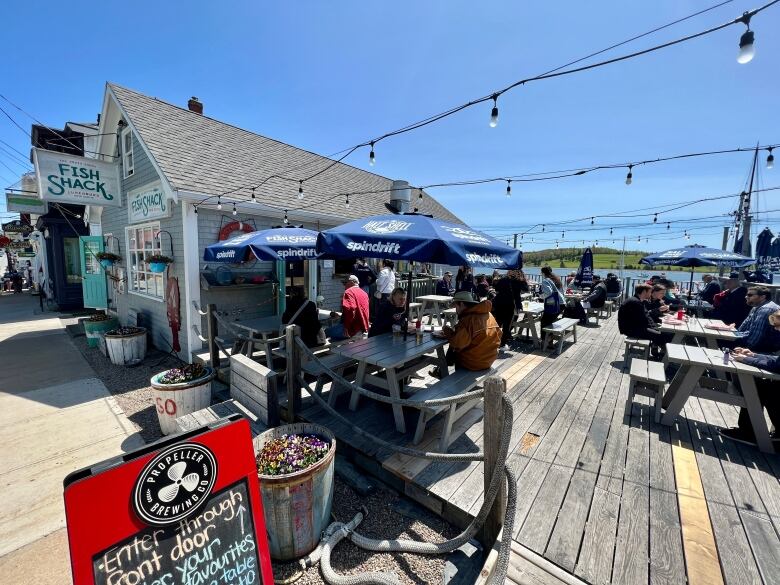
[64,415,273,585]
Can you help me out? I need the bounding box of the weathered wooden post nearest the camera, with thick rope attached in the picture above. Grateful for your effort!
[477,376,512,550]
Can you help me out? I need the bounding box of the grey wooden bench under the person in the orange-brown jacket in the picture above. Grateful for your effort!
[409,370,492,453]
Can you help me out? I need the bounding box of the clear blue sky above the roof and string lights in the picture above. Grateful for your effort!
[0,0,780,250]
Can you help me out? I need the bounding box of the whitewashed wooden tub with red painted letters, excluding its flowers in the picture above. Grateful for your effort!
[151,367,216,435]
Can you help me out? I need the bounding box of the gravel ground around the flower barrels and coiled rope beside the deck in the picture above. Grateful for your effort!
[66,320,459,585]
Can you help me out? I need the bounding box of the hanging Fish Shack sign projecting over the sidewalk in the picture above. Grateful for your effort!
[34,148,122,207]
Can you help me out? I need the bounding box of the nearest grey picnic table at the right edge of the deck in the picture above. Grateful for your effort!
[661,343,780,453]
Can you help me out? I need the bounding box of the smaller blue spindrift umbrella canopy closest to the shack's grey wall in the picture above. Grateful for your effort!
[203,226,317,264]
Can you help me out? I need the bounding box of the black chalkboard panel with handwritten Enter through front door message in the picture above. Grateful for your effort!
[92,481,263,585]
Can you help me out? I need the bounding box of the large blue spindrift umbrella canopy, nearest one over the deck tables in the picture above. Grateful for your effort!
[317,213,523,269]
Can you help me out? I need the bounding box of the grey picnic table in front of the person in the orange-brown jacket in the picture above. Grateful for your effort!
[330,332,447,433]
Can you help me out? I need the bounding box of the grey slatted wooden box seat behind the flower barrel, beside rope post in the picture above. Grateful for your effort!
[230,355,279,427]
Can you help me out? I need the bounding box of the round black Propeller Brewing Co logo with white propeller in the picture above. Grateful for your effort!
[133,443,217,526]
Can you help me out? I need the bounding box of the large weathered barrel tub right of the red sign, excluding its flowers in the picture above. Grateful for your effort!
[254,423,336,561]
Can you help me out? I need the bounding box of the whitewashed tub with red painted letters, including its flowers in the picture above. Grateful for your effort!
[151,364,216,435]
